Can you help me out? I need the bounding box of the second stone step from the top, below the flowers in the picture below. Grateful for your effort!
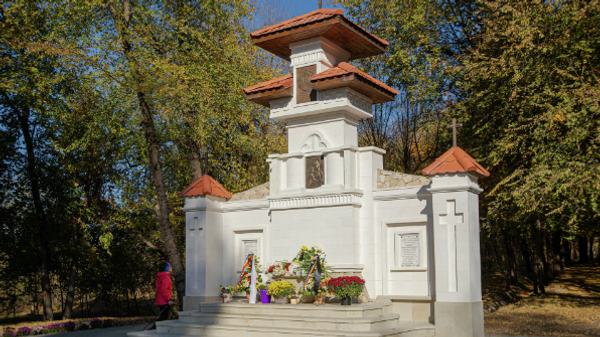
[173,310,400,333]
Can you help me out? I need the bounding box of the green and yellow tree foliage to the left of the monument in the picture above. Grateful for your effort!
[0,0,285,314]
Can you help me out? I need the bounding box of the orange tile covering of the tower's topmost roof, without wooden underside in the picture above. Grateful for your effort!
[250,8,389,46]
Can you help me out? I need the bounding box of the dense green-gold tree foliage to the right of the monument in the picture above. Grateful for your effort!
[456,1,600,233]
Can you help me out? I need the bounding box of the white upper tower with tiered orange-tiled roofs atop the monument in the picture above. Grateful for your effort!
[244,9,398,197]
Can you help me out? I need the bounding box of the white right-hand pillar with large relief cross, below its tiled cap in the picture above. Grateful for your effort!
[429,173,484,337]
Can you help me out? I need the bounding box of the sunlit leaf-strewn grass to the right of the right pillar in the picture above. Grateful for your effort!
[485,264,600,337]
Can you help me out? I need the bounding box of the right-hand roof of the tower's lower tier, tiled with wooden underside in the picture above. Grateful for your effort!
[310,62,398,103]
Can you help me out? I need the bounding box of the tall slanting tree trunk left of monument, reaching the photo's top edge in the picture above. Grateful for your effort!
[109,0,185,310]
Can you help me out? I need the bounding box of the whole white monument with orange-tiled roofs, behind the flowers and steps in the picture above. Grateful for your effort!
[180,9,489,336]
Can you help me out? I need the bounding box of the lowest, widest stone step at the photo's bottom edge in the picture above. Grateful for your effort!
[127,321,435,337]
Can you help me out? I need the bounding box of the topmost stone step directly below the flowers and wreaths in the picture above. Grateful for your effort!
[200,303,392,317]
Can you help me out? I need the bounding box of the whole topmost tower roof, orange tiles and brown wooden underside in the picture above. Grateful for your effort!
[250,8,389,61]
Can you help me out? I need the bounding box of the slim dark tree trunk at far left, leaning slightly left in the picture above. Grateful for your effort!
[15,108,53,321]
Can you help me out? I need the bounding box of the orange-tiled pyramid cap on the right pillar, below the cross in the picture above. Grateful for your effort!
[423,146,490,177]
